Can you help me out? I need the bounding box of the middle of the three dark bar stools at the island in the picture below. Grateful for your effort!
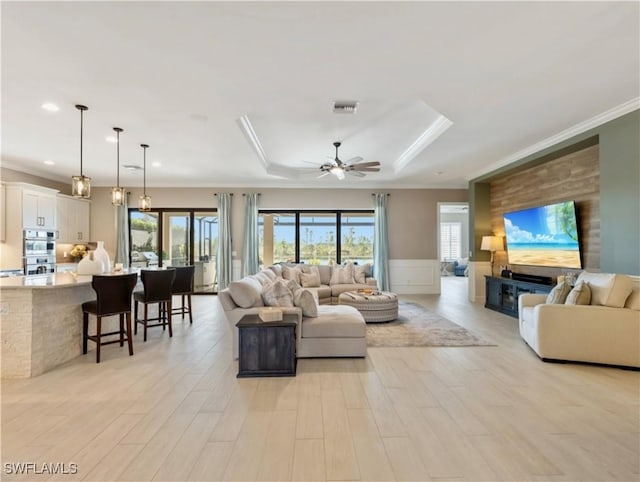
[133,268,176,341]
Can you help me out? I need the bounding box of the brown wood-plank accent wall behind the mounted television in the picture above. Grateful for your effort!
[490,144,600,278]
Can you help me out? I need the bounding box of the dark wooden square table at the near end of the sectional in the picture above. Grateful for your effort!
[236,314,298,378]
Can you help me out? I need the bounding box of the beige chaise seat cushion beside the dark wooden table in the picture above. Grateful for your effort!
[302,305,367,338]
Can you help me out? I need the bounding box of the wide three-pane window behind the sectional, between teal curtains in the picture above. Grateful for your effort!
[258,210,373,266]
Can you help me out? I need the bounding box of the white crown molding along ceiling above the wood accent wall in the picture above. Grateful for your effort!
[466,97,640,181]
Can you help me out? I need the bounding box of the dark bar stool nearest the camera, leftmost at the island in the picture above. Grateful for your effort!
[82,273,138,363]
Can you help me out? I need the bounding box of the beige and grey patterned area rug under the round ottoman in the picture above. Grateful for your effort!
[367,301,495,347]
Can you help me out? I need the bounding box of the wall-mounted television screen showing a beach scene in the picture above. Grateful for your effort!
[504,201,582,268]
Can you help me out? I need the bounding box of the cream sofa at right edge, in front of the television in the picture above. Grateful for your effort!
[518,271,640,368]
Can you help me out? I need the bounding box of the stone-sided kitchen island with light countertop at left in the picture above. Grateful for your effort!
[0,273,112,378]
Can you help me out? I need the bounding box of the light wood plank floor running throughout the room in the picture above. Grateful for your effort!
[0,278,640,481]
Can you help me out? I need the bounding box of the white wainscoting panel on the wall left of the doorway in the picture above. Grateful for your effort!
[389,259,440,295]
